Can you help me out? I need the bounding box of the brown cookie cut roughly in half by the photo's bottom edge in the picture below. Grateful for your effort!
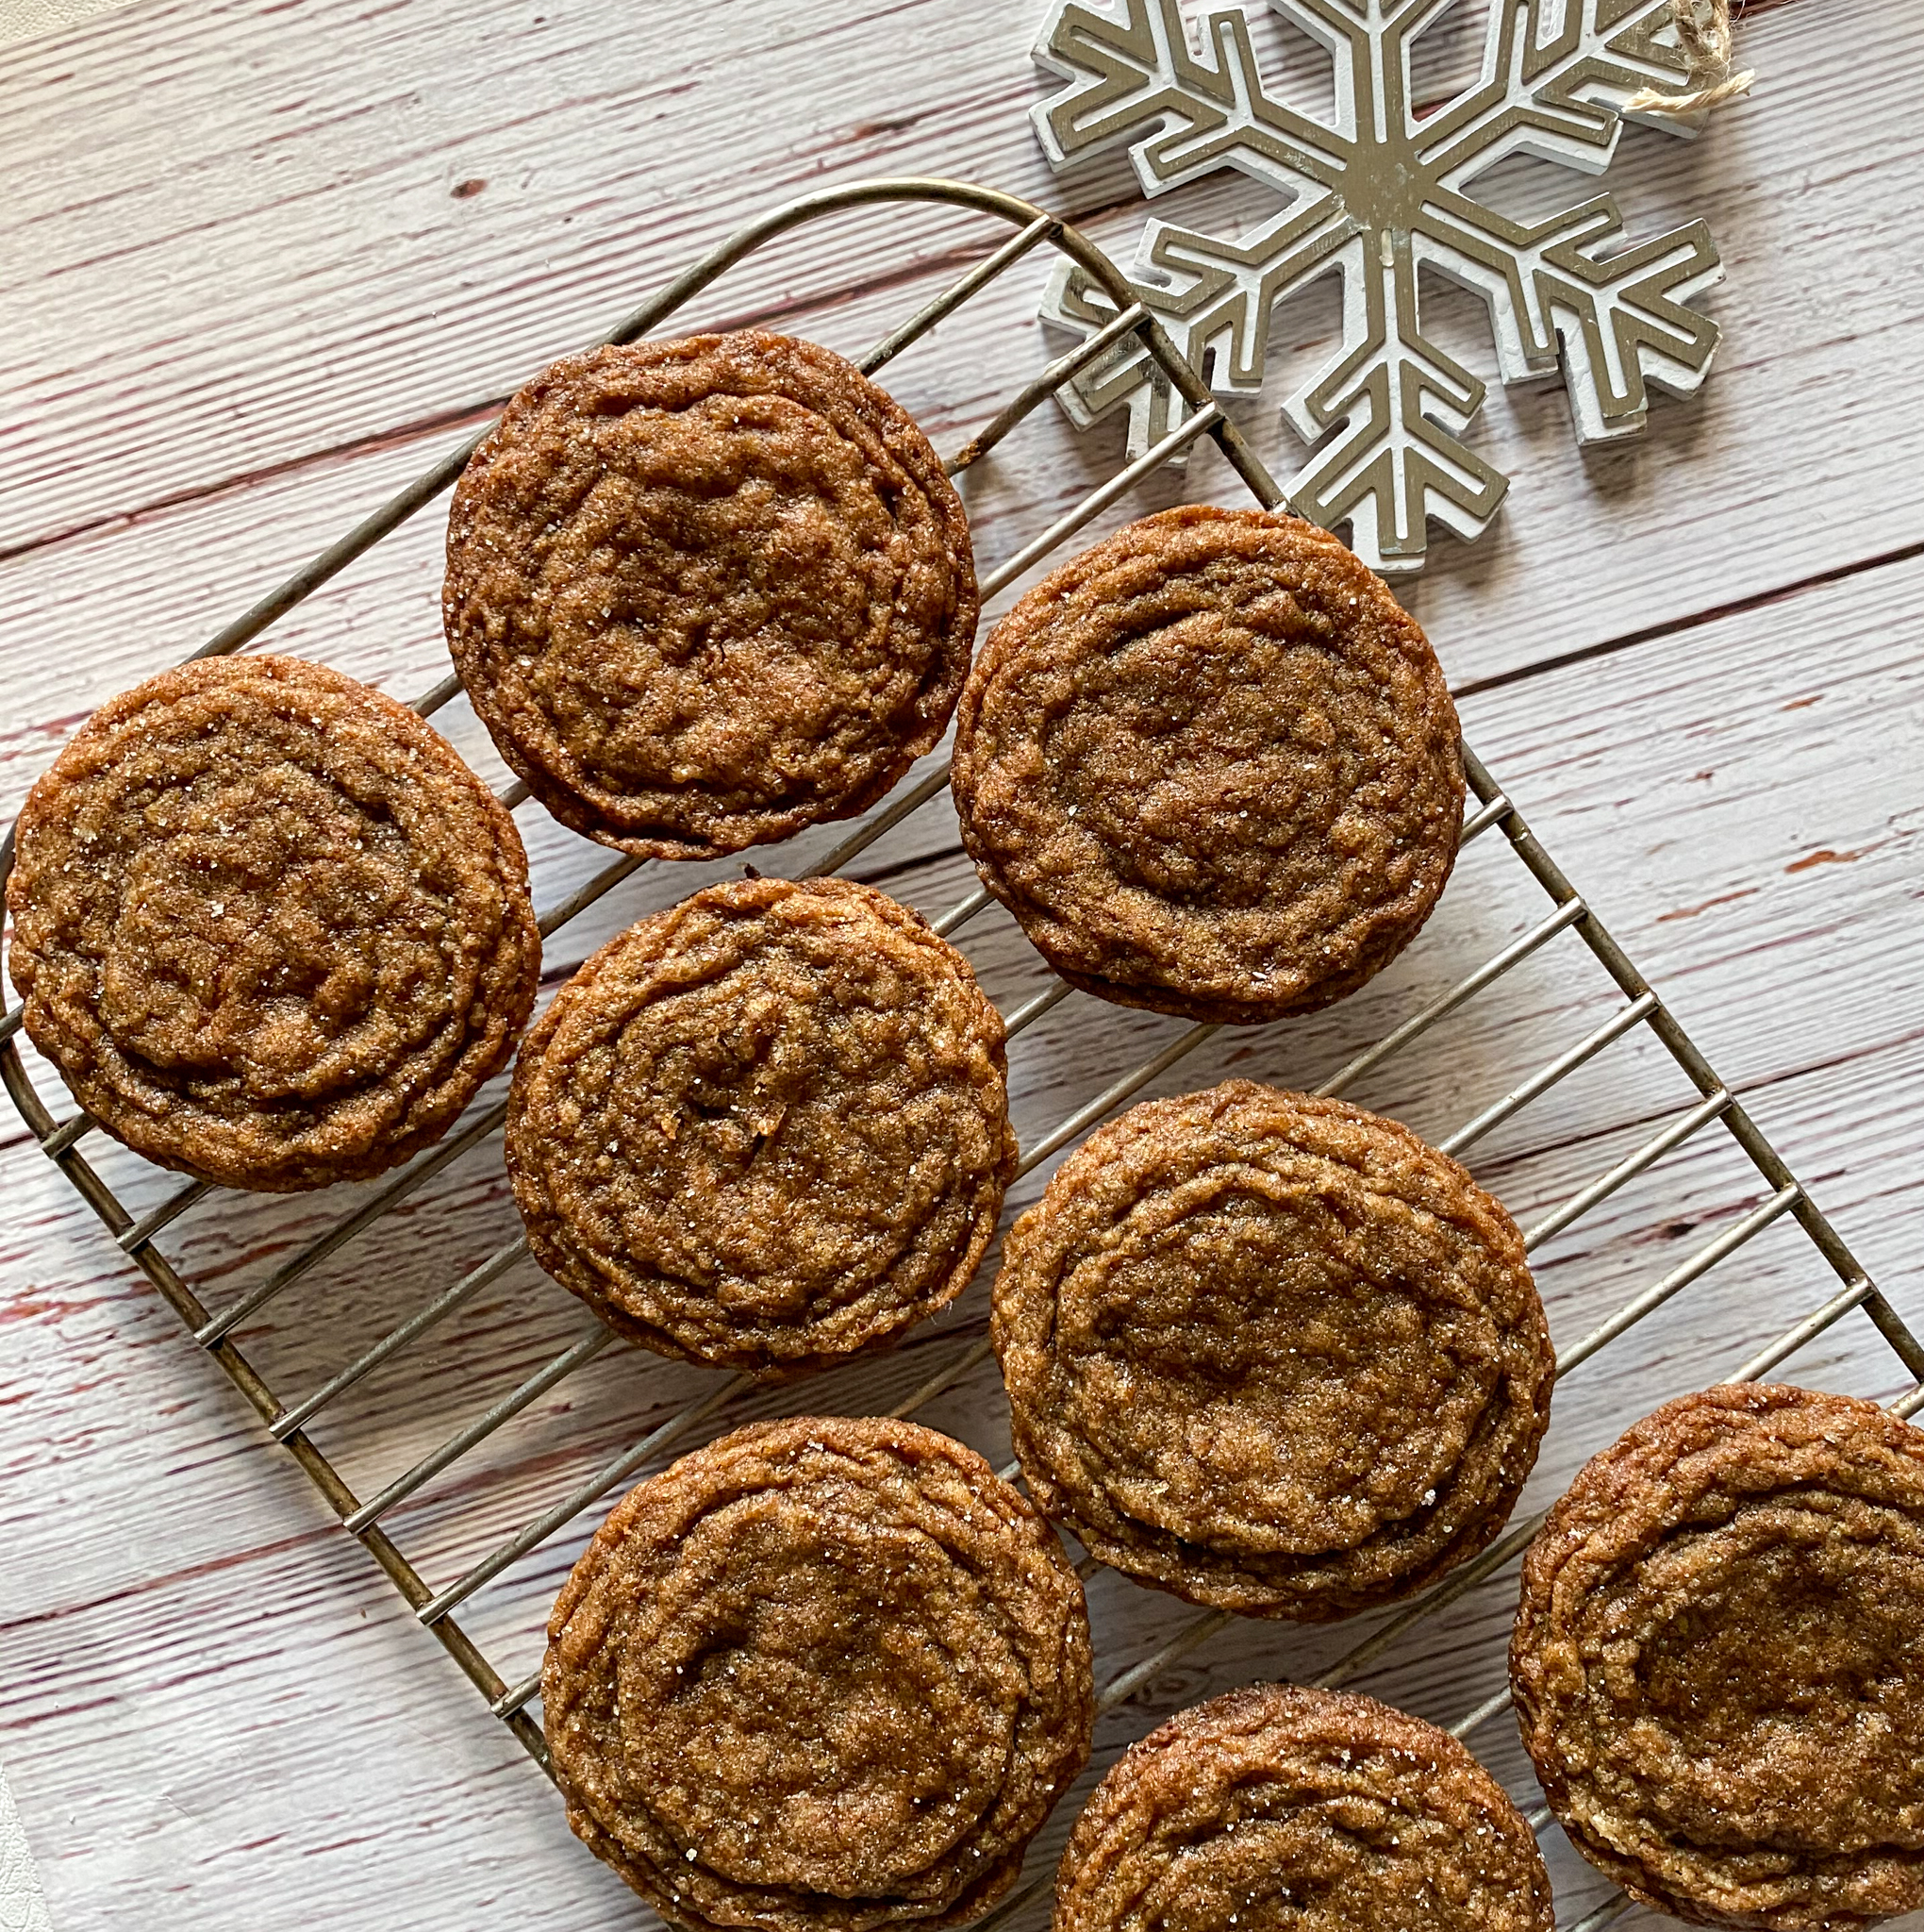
[1054,1685,1555,1932]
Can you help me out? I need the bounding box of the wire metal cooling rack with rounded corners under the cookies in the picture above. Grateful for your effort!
[0,177,1924,1932]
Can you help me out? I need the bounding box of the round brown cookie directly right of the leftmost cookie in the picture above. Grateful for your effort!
[508,879,1016,1372]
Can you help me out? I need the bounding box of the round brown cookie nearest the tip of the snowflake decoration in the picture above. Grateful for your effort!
[953,505,1462,1022]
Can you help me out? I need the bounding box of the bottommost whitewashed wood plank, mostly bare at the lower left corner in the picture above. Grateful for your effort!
[4,1051,1924,1932]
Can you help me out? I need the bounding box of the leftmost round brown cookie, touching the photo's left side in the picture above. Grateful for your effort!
[8,657,540,1192]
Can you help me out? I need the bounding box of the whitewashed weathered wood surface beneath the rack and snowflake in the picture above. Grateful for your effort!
[0,0,1924,1932]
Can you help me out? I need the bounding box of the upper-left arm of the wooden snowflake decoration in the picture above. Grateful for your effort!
[1032,0,1351,195]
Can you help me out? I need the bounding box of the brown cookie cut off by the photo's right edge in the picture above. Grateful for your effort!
[1511,1383,1924,1932]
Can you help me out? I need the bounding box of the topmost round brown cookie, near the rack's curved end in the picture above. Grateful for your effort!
[442,330,975,858]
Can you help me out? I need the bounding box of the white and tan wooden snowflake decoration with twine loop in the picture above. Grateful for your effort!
[1034,0,1723,572]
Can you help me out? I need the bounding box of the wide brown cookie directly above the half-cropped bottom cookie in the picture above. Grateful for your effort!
[991,1080,1555,1623]
